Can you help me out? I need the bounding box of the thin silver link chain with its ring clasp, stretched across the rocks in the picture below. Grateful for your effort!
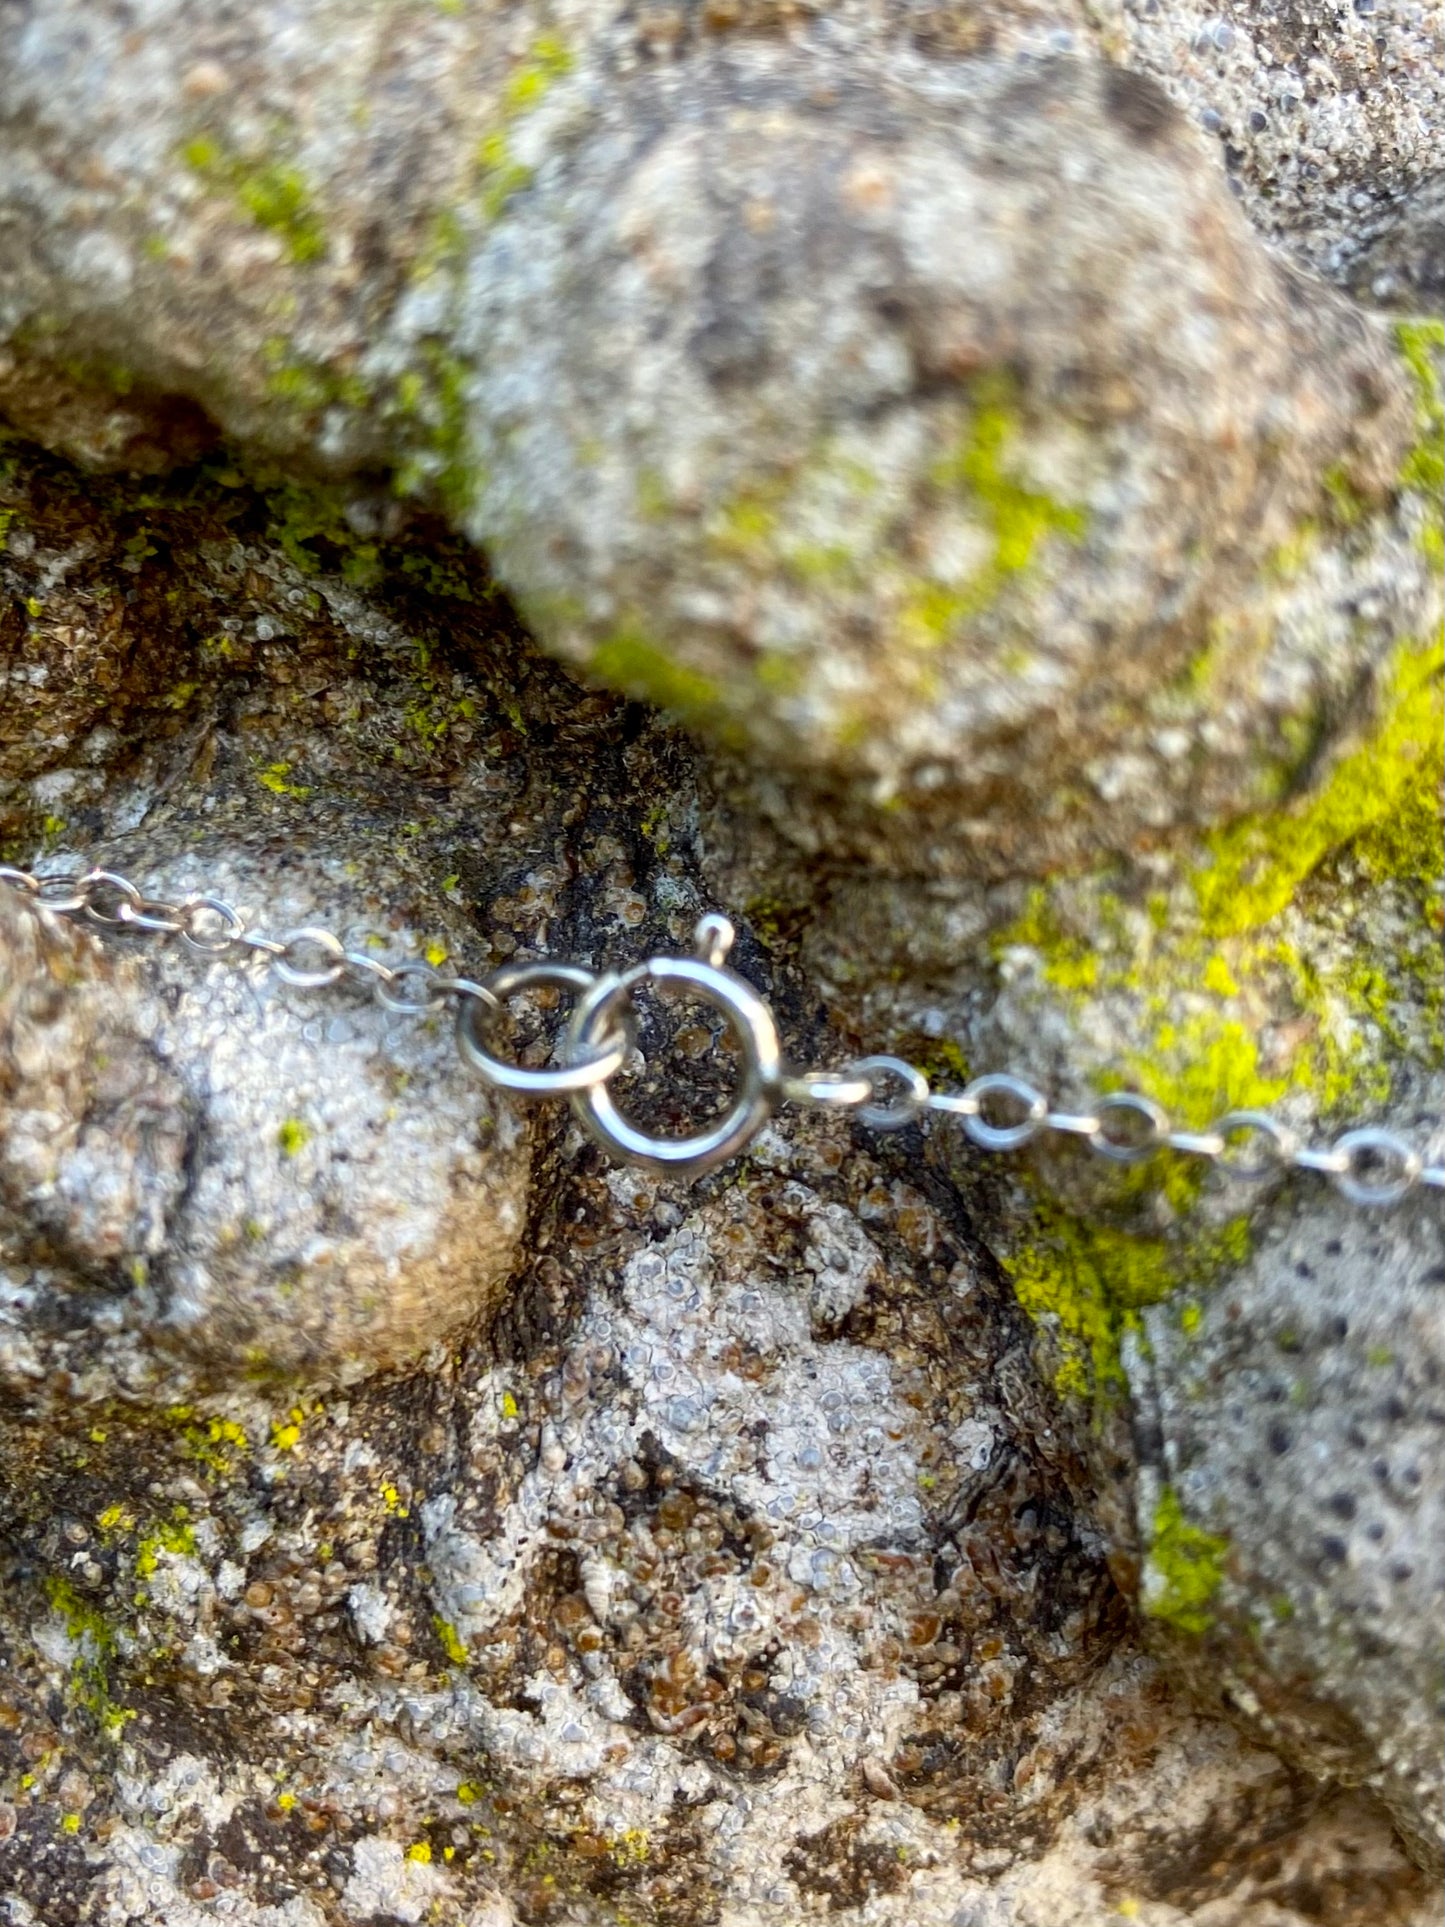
[0,865,1445,1204]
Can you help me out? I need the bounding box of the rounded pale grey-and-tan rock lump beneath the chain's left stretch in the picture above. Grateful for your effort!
[0,858,526,1395]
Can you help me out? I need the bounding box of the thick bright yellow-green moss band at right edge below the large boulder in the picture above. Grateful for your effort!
[1195,646,1443,937]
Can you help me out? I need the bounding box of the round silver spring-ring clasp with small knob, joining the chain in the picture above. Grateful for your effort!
[565,915,782,1177]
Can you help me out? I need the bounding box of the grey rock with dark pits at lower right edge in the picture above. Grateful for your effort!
[1129,1148,1445,1861]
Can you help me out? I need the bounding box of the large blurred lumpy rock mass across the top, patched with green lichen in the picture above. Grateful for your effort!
[0,0,1422,873]
